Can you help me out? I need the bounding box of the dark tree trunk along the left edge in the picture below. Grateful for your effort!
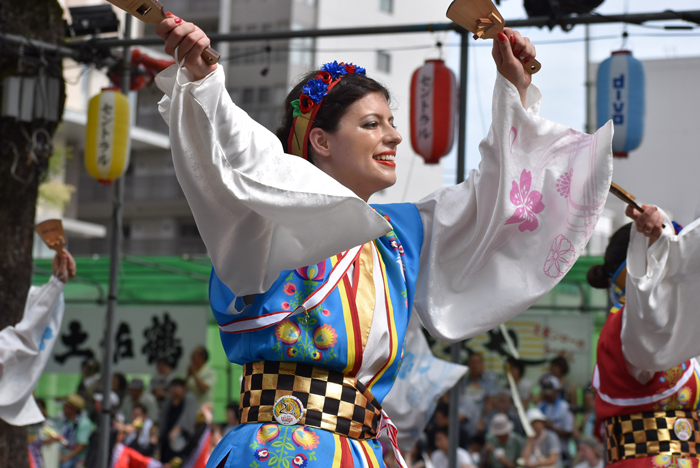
[0,0,65,468]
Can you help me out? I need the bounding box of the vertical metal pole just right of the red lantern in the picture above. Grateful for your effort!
[448,29,470,468]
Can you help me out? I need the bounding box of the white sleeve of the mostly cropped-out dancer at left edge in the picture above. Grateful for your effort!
[0,276,65,426]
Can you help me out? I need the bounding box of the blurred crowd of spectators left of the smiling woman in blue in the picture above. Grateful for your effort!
[30,346,227,468]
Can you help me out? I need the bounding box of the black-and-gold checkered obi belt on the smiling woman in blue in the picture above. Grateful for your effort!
[240,361,382,440]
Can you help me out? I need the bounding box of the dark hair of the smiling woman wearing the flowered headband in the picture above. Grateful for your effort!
[275,70,391,164]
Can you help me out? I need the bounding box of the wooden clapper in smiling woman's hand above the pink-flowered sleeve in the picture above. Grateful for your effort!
[448,0,542,75]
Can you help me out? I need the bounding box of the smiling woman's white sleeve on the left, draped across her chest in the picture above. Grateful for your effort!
[156,65,391,296]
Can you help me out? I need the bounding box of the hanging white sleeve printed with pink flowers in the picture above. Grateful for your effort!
[415,74,613,341]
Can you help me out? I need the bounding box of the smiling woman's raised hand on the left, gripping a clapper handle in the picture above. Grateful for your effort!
[156,12,216,80]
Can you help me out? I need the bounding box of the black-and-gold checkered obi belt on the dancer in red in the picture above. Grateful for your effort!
[605,411,700,463]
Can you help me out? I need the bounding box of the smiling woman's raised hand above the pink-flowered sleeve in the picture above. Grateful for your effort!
[492,28,536,106]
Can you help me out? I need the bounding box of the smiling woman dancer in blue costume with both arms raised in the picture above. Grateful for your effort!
[156,15,611,468]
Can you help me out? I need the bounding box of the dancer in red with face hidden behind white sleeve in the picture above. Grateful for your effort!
[588,206,700,468]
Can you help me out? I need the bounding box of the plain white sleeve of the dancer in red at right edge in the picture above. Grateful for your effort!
[621,216,700,373]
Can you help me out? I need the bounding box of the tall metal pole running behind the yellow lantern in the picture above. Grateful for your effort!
[98,15,131,468]
